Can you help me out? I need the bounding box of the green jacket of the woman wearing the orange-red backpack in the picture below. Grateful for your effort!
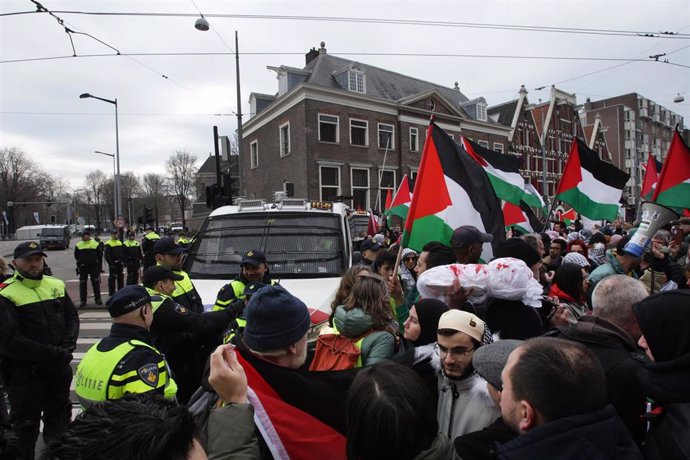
[333,305,395,366]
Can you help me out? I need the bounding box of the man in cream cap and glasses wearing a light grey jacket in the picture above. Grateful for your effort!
[435,310,494,439]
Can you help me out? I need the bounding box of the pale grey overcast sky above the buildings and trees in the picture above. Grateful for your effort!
[0,0,690,188]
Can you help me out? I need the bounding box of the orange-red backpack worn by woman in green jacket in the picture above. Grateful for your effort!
[309,326,375,371]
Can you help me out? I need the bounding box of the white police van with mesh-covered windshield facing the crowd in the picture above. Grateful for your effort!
[183,198,352,324]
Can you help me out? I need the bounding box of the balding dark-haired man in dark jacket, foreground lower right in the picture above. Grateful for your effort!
[496,337,642,460]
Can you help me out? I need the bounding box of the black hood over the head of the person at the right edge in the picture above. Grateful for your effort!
[633,289,690,362]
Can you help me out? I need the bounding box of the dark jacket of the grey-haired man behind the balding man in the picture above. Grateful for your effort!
[547,316,648,444]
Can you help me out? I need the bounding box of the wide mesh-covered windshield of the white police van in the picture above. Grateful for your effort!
[183,212,347,279]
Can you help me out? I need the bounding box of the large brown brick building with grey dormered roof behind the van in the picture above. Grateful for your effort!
[242,42,509,209]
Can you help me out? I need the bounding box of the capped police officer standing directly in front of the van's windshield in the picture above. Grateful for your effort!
[213,249,276,327]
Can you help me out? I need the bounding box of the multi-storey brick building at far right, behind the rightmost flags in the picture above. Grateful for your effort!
[582,93,684,204]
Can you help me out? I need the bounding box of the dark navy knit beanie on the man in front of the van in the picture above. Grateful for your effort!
[242,284,311,351]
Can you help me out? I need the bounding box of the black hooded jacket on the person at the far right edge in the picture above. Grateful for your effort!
[633,290,690,459]
